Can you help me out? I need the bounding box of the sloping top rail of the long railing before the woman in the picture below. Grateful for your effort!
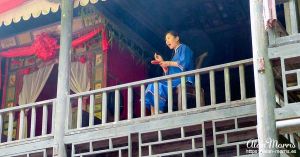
[70,58,252,98]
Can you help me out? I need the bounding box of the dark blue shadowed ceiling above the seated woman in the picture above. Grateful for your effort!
[98,0,251,63]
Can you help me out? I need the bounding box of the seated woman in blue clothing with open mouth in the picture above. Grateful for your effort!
[145,31,194,115]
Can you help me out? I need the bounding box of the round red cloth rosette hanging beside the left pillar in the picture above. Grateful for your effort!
[32,33,59,61]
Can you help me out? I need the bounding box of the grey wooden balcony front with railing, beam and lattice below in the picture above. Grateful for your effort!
[0,59,299,156]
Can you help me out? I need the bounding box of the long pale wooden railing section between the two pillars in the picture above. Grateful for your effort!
[67,59,254,129]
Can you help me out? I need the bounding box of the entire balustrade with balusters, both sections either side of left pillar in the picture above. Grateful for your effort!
[0,59,254,144]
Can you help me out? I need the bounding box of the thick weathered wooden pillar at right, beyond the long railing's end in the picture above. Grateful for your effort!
[249,0,279,157]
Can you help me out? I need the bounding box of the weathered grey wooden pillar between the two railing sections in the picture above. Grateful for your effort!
[53,0,73,157]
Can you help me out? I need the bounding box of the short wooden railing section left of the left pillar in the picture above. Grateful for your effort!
[0,99,55,143]
